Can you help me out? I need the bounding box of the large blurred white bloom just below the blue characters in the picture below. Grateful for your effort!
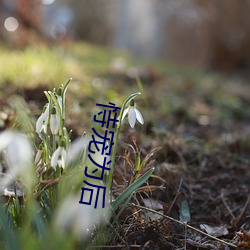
[54,195,106,240]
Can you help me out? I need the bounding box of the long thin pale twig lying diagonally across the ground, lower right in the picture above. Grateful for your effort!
[128,203,237,248]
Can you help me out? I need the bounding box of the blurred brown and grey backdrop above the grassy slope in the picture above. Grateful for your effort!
[0,0,250,72]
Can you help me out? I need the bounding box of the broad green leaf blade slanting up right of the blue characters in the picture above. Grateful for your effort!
[112,168,155,211]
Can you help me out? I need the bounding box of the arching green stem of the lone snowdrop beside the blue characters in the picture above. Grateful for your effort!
[107,92,141,203]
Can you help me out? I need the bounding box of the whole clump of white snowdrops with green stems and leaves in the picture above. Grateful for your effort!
[0,80,154,250]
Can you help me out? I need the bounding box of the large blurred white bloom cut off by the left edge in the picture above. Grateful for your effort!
[0,130,33,188]
